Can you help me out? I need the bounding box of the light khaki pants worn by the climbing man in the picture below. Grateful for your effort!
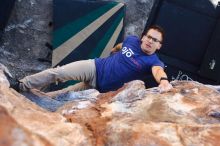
[20,59,96,91]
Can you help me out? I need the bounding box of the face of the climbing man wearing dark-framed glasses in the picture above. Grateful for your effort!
[141,29,162,55]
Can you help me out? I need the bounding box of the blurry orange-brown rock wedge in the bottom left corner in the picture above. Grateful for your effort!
[0,106,51,146]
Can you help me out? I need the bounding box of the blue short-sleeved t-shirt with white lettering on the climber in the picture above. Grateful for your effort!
[95,36,164,92]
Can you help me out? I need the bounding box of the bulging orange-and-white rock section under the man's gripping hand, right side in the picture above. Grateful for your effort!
[61,81,220,146]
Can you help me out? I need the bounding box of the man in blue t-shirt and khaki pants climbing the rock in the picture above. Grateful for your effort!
[9,26,172,92]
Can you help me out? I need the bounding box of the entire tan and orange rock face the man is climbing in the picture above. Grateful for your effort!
[0,65,220,146]
